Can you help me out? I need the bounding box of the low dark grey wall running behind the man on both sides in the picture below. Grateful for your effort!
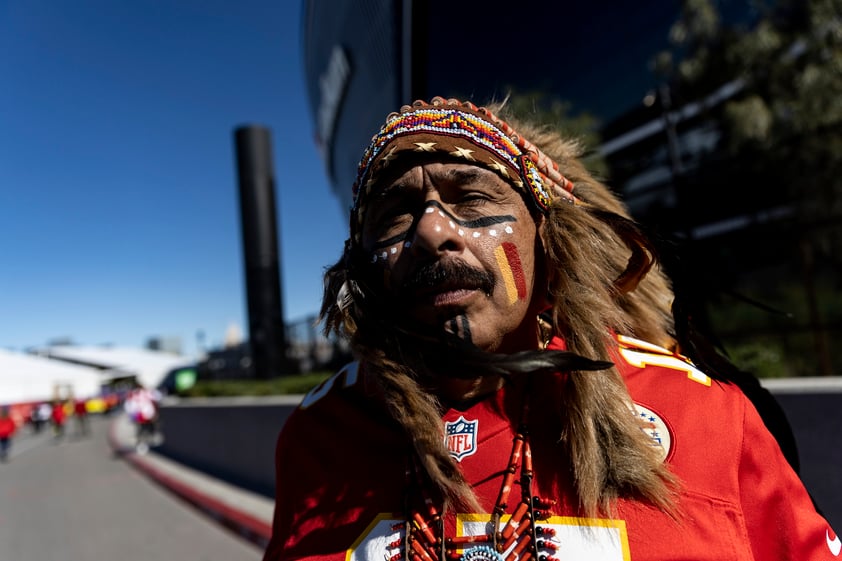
[156,378,842,531]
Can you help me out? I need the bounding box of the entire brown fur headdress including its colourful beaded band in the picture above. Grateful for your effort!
[321,98,672,514]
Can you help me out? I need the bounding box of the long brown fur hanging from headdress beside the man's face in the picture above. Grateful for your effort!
[321,98,675,516]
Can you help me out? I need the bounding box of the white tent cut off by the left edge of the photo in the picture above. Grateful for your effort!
[0,349,103,405]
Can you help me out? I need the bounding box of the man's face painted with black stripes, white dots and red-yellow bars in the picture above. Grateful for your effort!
[361,162,542,352]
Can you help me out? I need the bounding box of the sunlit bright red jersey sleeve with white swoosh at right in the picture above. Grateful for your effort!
[739,394,842,561]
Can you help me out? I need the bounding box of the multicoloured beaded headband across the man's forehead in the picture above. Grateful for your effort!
[351,97,576,243]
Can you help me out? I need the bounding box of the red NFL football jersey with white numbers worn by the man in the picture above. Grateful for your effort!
[264,337,842,561]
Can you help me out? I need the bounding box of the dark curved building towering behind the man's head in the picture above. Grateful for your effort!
[303,0,842,376]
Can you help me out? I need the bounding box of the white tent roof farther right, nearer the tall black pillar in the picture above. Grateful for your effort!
[40,345,192,388]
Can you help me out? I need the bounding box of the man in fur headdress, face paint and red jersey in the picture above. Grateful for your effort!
[264,98,842,561]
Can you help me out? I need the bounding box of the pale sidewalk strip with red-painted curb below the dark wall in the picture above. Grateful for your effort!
[108,413,274,549]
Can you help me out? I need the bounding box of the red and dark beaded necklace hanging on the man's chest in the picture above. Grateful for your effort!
[398,388,559,561]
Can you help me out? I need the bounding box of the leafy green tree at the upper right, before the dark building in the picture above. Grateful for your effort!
[653,0,842,374]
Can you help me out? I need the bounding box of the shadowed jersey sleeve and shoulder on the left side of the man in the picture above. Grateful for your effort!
[263,366,390,561]
